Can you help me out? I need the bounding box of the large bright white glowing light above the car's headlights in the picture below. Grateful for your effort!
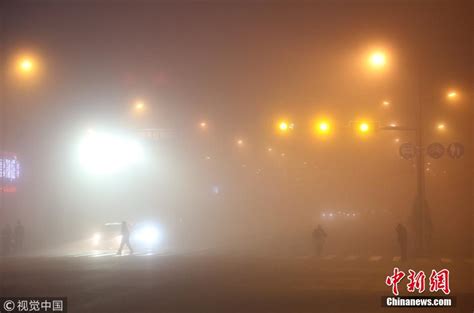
[78,130,144,175]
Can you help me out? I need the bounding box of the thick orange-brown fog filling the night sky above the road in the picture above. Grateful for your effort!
[0,1,474,255]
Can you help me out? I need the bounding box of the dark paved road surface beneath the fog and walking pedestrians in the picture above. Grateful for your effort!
[0,250,474,313]
